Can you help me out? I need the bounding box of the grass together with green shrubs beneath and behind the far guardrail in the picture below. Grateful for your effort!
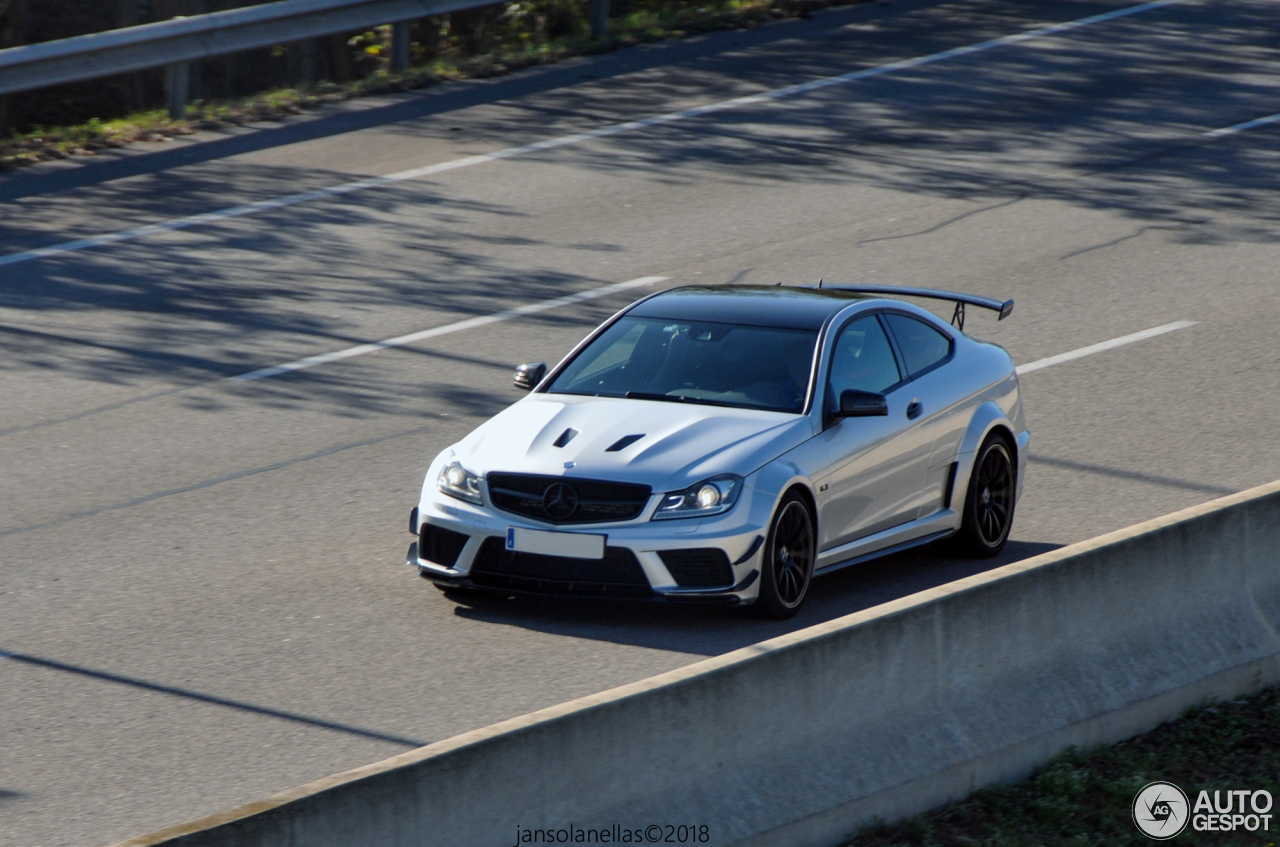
[0,0,860,170]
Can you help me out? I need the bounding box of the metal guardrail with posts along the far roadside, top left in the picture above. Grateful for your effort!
[0,0,609,118]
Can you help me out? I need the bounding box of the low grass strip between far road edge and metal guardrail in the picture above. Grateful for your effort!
[0,0,865,171]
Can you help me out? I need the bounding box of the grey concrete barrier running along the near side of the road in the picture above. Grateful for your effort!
[112,482,1280,847]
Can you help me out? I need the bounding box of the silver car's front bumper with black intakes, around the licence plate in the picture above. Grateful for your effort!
[406,489,773,605]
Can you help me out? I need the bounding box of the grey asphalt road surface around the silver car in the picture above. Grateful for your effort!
[0,0,1280,847]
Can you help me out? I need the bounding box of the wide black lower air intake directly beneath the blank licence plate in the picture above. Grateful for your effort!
[470,537,653,598]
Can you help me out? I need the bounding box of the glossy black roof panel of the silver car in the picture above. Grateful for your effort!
[627,285,865,330]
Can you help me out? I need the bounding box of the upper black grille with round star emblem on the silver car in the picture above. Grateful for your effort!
[485,473,653,523]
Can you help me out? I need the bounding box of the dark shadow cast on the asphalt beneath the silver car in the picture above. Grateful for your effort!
[447,541,1064,656]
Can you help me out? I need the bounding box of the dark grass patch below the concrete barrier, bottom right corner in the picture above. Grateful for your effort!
[846,688,1280,847]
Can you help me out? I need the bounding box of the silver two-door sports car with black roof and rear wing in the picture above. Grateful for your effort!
[408,285,1030,618]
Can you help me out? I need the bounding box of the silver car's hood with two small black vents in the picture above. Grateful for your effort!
[453,394,813,491]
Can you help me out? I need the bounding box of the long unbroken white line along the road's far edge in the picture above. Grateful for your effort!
[0,0,1184,272]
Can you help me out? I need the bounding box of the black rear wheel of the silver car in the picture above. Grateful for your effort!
[955,434,1018,559]
